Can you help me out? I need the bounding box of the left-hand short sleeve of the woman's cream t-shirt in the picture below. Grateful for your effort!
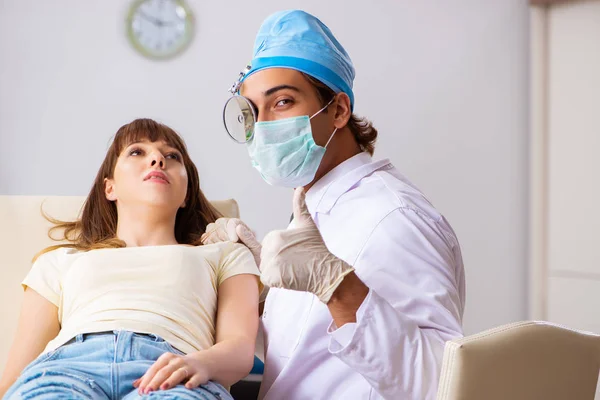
[21,249,64,307]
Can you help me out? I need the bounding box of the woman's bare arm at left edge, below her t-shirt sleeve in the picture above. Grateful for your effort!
[0,288,60,398]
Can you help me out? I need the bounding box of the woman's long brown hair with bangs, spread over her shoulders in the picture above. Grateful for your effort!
[34,119,222,261]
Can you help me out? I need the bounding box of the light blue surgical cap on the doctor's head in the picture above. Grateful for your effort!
[244,10,354,108]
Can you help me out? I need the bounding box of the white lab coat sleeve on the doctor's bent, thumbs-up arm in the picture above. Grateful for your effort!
[328,208,464,400]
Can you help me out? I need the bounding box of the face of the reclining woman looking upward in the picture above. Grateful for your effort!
[104,140,188,213]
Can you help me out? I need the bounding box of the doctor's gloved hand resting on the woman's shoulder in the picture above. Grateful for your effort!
[200,218,262,265]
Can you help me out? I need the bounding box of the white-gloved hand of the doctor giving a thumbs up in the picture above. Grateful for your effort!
[260,187,354,304]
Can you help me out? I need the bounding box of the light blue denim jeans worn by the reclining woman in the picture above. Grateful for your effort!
[4,331,232,400]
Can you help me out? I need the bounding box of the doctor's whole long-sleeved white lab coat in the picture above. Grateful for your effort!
[259,153,465,400]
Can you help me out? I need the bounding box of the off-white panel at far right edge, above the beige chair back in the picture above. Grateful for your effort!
[545,0,600,334]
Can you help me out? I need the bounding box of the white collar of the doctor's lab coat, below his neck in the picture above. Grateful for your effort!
[306,152,390,218]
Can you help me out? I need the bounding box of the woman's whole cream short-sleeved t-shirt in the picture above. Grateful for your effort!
[22,242,260,353]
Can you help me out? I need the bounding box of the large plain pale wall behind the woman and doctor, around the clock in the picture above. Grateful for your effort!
[0,0,528,333]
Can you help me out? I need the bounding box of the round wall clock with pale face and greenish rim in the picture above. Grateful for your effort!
[127,0,194,59]
